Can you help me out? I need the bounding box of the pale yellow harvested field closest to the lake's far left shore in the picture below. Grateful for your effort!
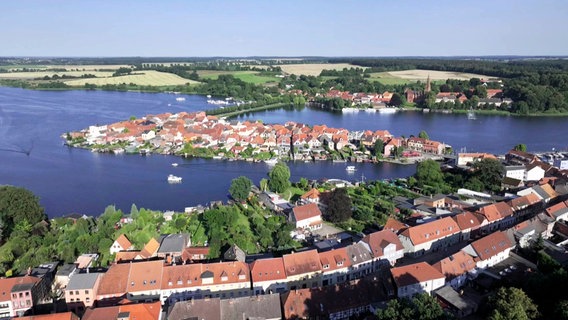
[65,70,199,86]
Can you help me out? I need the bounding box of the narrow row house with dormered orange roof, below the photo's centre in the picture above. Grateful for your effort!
[318,248,351,286]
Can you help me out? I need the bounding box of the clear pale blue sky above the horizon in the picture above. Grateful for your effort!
[0,0,568,57]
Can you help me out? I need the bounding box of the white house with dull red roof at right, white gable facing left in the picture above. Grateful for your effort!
[462,231,515,269]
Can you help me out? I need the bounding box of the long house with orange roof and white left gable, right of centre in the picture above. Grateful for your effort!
[398,217,461,256]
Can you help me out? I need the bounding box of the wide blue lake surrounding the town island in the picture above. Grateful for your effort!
[0,87,568,217]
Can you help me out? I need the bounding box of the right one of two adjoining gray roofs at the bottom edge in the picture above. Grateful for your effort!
[221,293,282,320]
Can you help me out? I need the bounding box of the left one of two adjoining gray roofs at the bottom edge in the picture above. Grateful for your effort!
[168,298,221,320]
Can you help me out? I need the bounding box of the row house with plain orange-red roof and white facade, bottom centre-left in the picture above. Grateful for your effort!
[250,258,287,295]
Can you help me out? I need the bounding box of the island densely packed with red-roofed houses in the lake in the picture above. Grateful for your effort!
[63,111,451,163]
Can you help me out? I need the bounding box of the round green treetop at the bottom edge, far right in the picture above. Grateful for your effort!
[489,287,539,320]
